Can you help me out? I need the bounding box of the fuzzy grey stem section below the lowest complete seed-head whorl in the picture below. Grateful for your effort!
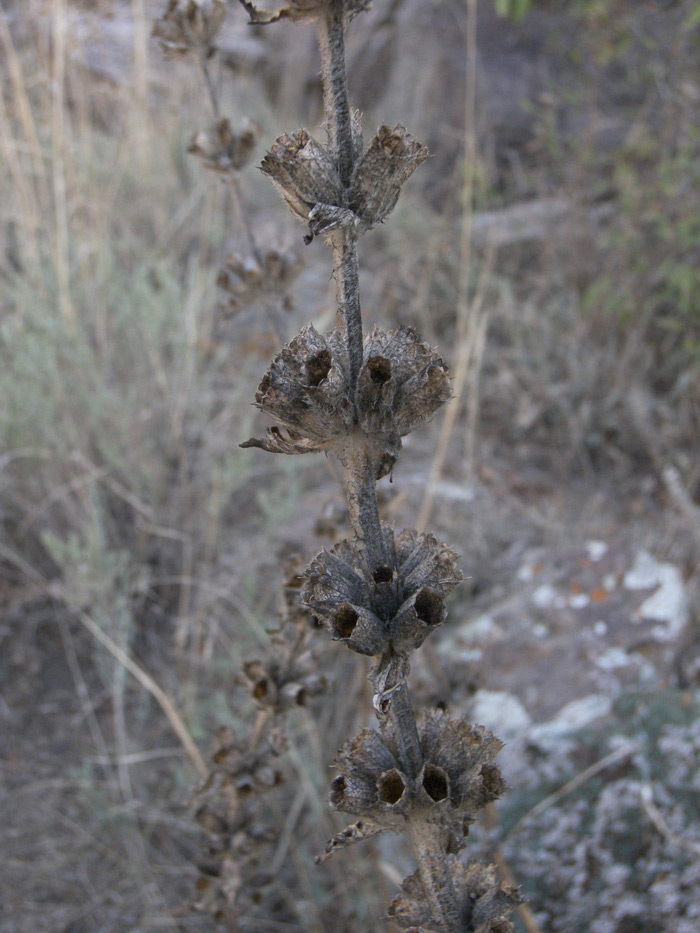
[406,820,464,933]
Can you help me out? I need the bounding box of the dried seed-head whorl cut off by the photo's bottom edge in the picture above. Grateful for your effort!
[389,858,522,933]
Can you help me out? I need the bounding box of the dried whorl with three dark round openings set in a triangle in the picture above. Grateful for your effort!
[302,525,462,656]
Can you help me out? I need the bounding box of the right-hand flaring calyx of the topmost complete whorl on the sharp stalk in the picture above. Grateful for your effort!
[350,123,429,228]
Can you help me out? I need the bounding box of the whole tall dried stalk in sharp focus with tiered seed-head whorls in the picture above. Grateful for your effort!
[232,0,519,933]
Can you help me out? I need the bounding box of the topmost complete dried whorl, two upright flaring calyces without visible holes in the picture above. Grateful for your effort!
[261,122,428,242]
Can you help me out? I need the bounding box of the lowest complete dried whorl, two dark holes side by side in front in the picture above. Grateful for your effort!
[330,710,505,836]
